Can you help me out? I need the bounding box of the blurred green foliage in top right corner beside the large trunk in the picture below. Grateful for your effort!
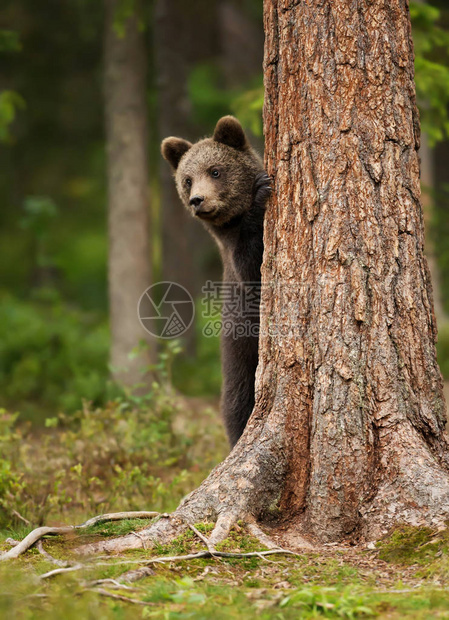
[410,2,449,145]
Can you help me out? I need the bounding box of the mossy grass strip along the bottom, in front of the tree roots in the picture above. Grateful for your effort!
[0,520,449,620]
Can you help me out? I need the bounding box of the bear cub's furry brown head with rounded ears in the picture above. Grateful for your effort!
[161,116,263,226]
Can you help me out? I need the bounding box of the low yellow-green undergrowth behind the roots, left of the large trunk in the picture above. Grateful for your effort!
[0,390,226,524]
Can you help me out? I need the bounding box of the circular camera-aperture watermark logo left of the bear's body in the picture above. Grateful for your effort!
[137,282,195,339]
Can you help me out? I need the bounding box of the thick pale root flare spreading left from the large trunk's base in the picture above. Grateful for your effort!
[76,406,286,555]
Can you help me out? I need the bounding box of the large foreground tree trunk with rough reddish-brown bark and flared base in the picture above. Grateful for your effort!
[83,0,449,550]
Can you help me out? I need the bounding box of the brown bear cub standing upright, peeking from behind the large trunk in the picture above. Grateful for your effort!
[161,116,270,447]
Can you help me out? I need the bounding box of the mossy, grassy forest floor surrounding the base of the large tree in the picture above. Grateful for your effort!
[0,394,449,620]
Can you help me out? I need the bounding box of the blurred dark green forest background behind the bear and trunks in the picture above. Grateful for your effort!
[0,0,449,424]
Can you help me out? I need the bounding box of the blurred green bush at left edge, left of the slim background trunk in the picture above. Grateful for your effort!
[0,289,114,420]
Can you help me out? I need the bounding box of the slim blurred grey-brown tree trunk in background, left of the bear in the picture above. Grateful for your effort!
[104,0,152,386]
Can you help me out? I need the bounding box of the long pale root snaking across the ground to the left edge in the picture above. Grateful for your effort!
[0,510,160,561]
